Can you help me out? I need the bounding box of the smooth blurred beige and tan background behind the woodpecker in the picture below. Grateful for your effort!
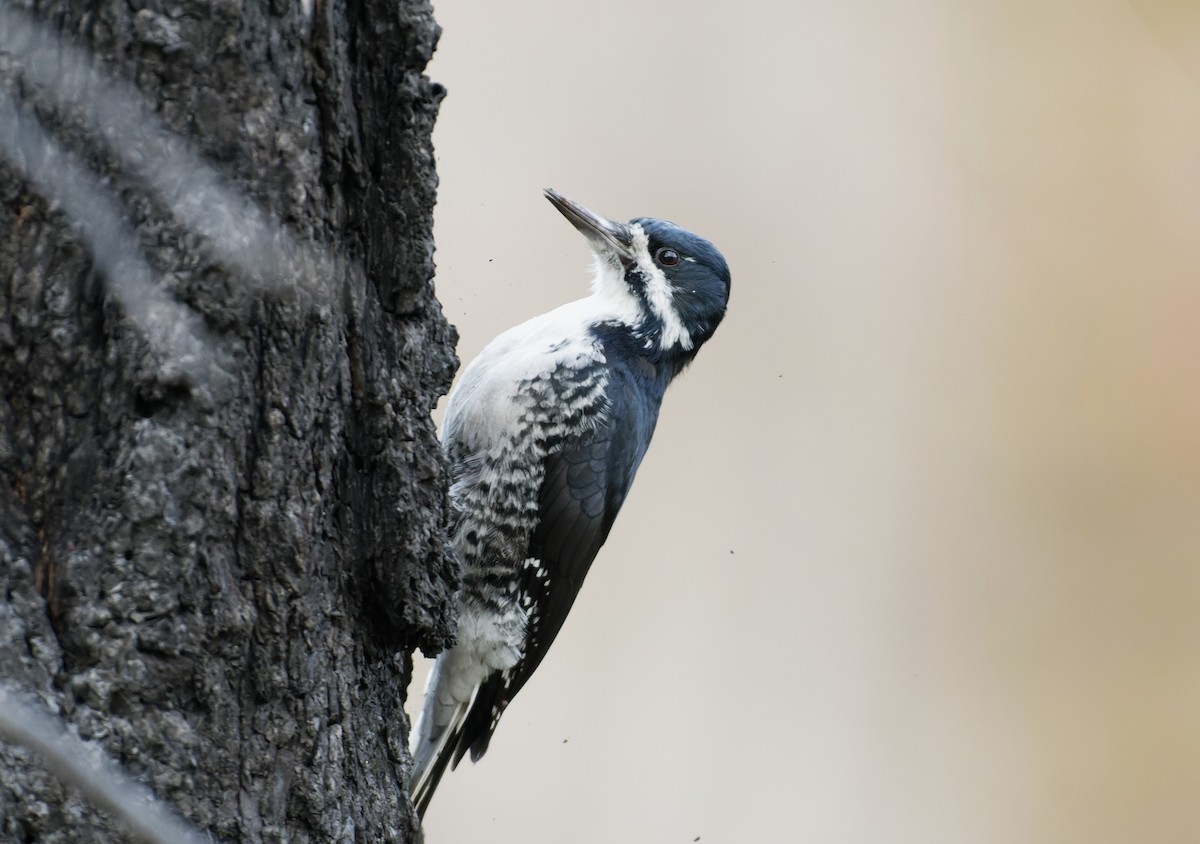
[409,0,1200,844]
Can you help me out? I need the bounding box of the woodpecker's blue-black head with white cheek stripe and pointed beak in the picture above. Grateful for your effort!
[546,188,730,366]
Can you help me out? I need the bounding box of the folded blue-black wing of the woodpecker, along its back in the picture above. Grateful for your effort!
[454,362,665,765]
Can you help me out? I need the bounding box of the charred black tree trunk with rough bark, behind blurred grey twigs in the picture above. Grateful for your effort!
[0,0,458,843]
